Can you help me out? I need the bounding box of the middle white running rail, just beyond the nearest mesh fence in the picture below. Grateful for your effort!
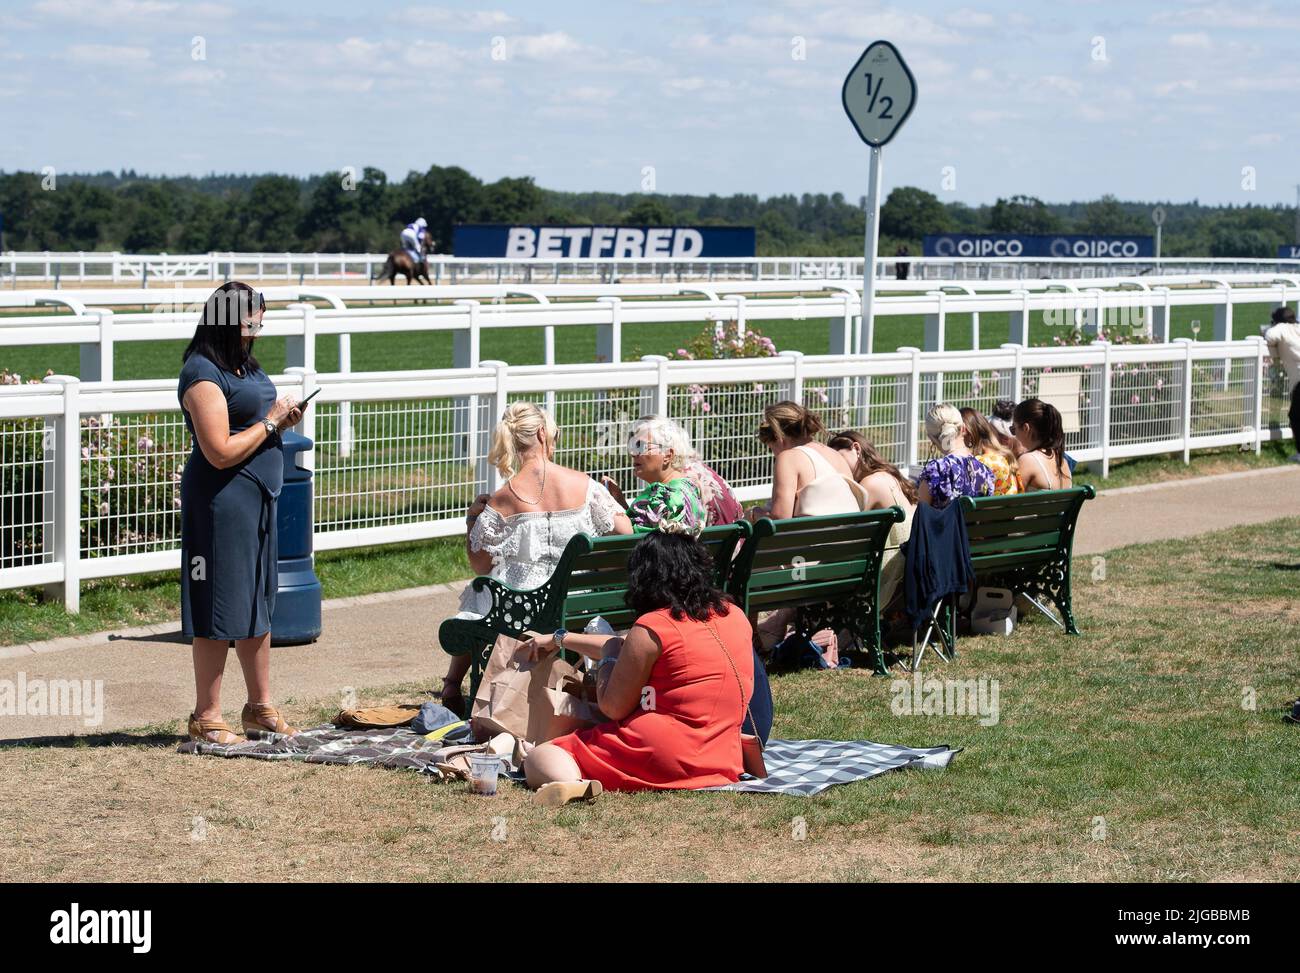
[0,274,1300,381]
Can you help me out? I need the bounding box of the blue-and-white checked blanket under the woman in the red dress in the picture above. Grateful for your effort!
[706,740,958,797]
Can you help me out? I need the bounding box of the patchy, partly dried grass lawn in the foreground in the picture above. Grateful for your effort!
[0,518,1300,882]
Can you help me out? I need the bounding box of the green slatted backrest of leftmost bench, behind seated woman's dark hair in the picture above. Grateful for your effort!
[553,522,750,632]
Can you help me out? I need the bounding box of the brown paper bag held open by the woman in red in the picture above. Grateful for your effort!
[469,635,605,744]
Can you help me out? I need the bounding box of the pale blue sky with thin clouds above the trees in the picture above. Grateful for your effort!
[0,0,1300,203]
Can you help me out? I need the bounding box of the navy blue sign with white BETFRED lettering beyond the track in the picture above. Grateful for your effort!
[452,225,754,260]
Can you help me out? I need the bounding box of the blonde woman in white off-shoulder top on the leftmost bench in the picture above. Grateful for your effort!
[442,402,632,713]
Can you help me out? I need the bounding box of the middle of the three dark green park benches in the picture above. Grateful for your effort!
[728,507,904,675]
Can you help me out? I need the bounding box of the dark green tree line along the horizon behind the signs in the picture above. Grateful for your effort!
[0,165,1300,258]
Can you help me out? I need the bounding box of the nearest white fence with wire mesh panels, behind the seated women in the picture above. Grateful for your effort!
[0,335,1286,610]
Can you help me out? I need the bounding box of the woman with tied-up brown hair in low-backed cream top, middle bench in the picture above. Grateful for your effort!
[750,402,866,520]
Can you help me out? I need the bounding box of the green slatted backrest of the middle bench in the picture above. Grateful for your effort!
[729,507,904,615]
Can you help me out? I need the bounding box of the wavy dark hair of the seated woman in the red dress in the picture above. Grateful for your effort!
[625,531,727,622]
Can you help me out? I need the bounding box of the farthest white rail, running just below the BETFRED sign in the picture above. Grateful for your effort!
[0,251,1300,285]
